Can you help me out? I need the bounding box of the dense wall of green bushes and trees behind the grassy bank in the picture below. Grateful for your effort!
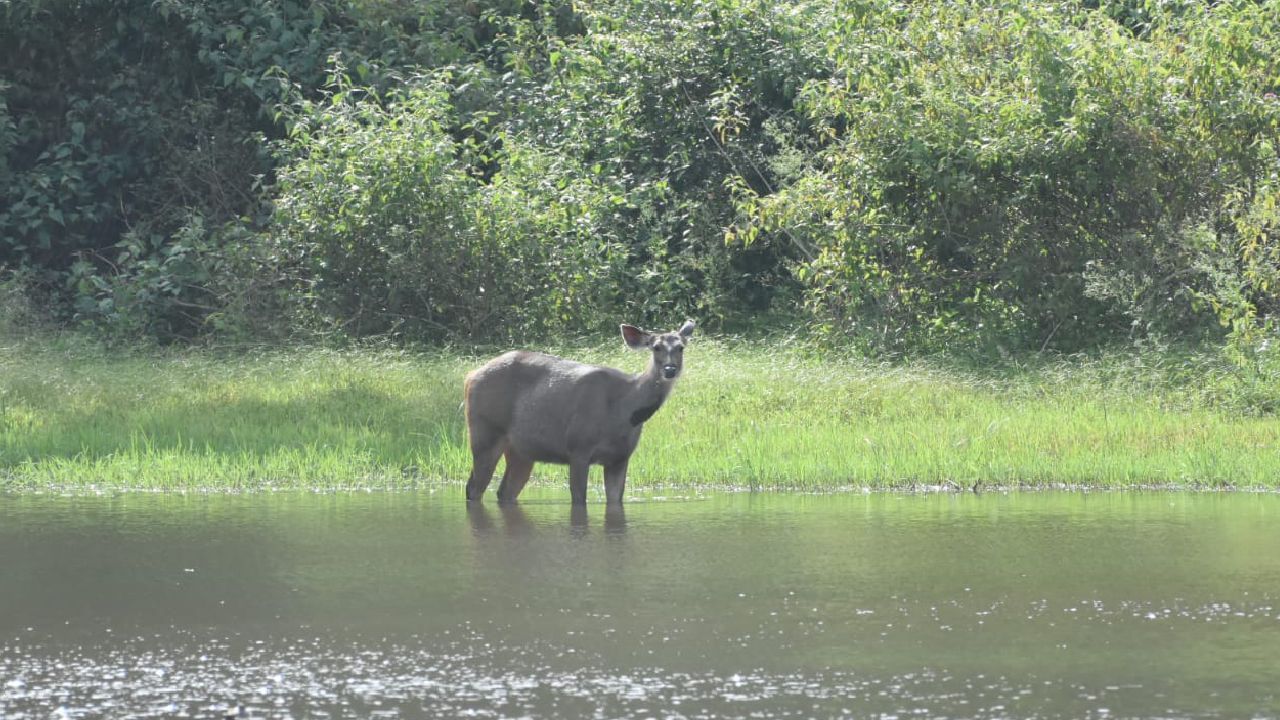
[0,0,1280,356]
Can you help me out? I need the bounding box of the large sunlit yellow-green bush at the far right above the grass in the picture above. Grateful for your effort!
[741,1,1280,348]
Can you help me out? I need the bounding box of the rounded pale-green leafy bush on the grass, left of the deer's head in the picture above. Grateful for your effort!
[273,79,627,341]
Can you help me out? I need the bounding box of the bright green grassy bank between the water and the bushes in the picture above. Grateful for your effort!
[0,341,1280,493]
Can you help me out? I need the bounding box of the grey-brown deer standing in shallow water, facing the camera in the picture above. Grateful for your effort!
[462,320,694,507]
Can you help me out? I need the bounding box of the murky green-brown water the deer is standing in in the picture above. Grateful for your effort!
[0,488,1280,720]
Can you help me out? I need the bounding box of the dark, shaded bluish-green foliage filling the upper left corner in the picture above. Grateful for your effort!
[0,0,520,337]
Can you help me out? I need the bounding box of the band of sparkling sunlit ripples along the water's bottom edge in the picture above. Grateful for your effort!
[0,632,1259,720]
